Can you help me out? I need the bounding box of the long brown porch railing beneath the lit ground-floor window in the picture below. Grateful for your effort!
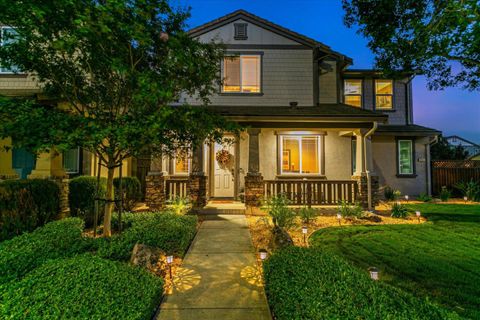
[264,179,358,205]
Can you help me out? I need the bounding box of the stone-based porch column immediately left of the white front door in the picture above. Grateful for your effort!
[188,143,207,210]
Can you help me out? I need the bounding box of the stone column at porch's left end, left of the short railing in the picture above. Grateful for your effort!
[145,155,168,210]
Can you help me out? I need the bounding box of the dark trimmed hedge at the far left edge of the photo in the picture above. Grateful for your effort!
[0,179,60,240]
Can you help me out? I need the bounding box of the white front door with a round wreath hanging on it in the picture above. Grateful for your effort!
[213,143,235,198]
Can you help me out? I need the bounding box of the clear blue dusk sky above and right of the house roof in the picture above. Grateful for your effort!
[178,0,480,143]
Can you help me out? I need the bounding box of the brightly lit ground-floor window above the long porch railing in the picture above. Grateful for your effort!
[280,136,320,174]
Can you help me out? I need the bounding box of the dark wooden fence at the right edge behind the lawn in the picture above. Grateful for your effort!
[432,160,480,194]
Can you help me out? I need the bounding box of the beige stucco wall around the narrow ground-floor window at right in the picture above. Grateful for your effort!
[372,136,427,196]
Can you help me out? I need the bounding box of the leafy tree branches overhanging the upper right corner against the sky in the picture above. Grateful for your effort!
[342,0,480,90]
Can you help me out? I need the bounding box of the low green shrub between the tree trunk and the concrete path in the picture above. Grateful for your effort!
[98,212,198,261]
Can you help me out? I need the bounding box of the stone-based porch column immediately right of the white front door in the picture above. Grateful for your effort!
[245,128,264,207]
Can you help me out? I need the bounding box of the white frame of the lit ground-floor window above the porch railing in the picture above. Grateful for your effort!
[277,134,324,177]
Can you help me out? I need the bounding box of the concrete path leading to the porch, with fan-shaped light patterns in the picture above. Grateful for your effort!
[157,215,271,320]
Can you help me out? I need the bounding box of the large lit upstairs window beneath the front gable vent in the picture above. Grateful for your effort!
[222,54,261,93]
